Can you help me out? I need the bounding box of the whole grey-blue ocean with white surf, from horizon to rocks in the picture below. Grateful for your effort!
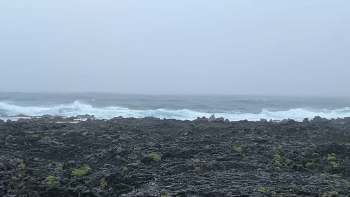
[0,93,350,121]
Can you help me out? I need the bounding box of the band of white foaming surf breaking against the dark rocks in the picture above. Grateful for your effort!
[0,101,350,121]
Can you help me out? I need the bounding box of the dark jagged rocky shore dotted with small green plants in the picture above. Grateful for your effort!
[0,118,350,197]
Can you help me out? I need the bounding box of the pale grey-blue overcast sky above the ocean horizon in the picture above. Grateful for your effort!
[0,0,350,96]
